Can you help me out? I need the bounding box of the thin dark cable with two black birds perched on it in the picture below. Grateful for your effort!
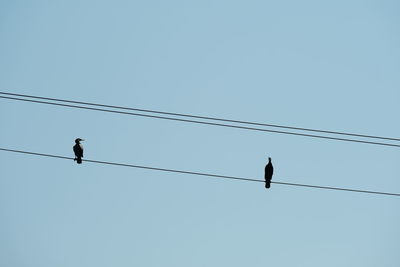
[0,148,400,197]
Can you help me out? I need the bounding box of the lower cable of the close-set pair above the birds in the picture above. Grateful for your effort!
[0,96,400,147]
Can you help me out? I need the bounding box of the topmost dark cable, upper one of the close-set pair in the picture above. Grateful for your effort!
[0,91,400,141]
